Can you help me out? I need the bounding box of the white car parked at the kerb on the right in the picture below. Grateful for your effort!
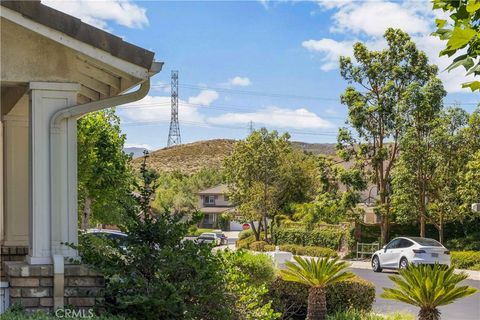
[372,237,450,272]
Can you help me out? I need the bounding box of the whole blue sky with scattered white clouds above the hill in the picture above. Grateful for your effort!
[43,0,480,149]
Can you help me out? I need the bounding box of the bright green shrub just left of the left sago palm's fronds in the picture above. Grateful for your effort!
[220,250,275,286]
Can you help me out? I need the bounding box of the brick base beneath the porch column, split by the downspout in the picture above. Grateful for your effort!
[3,261,105,311]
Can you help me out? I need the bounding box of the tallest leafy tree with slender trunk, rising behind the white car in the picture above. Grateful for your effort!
[337,28,437,242]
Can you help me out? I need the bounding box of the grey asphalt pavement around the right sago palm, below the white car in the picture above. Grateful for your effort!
[350,268,480,320]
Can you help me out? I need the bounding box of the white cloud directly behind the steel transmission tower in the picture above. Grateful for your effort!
[117,95,204,123]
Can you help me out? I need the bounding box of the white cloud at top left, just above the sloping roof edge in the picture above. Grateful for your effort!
[42,0,148,30]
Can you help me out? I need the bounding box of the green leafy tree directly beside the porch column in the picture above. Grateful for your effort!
[77,109,132,229]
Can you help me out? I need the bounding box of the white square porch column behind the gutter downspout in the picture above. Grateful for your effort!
[27,82,80,264]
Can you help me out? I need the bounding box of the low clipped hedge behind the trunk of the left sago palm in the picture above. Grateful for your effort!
[269,277,375,319]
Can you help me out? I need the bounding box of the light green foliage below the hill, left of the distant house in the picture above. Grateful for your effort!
[153,168,225,213]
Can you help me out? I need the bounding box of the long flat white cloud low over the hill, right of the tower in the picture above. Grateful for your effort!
[207,107,335,129]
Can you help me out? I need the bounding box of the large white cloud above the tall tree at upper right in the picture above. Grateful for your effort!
[302,0,473,92]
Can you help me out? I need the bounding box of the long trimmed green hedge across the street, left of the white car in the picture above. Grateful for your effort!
[273,227,349,250]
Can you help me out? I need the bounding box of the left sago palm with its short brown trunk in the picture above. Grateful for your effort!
[280,256,354,320]
